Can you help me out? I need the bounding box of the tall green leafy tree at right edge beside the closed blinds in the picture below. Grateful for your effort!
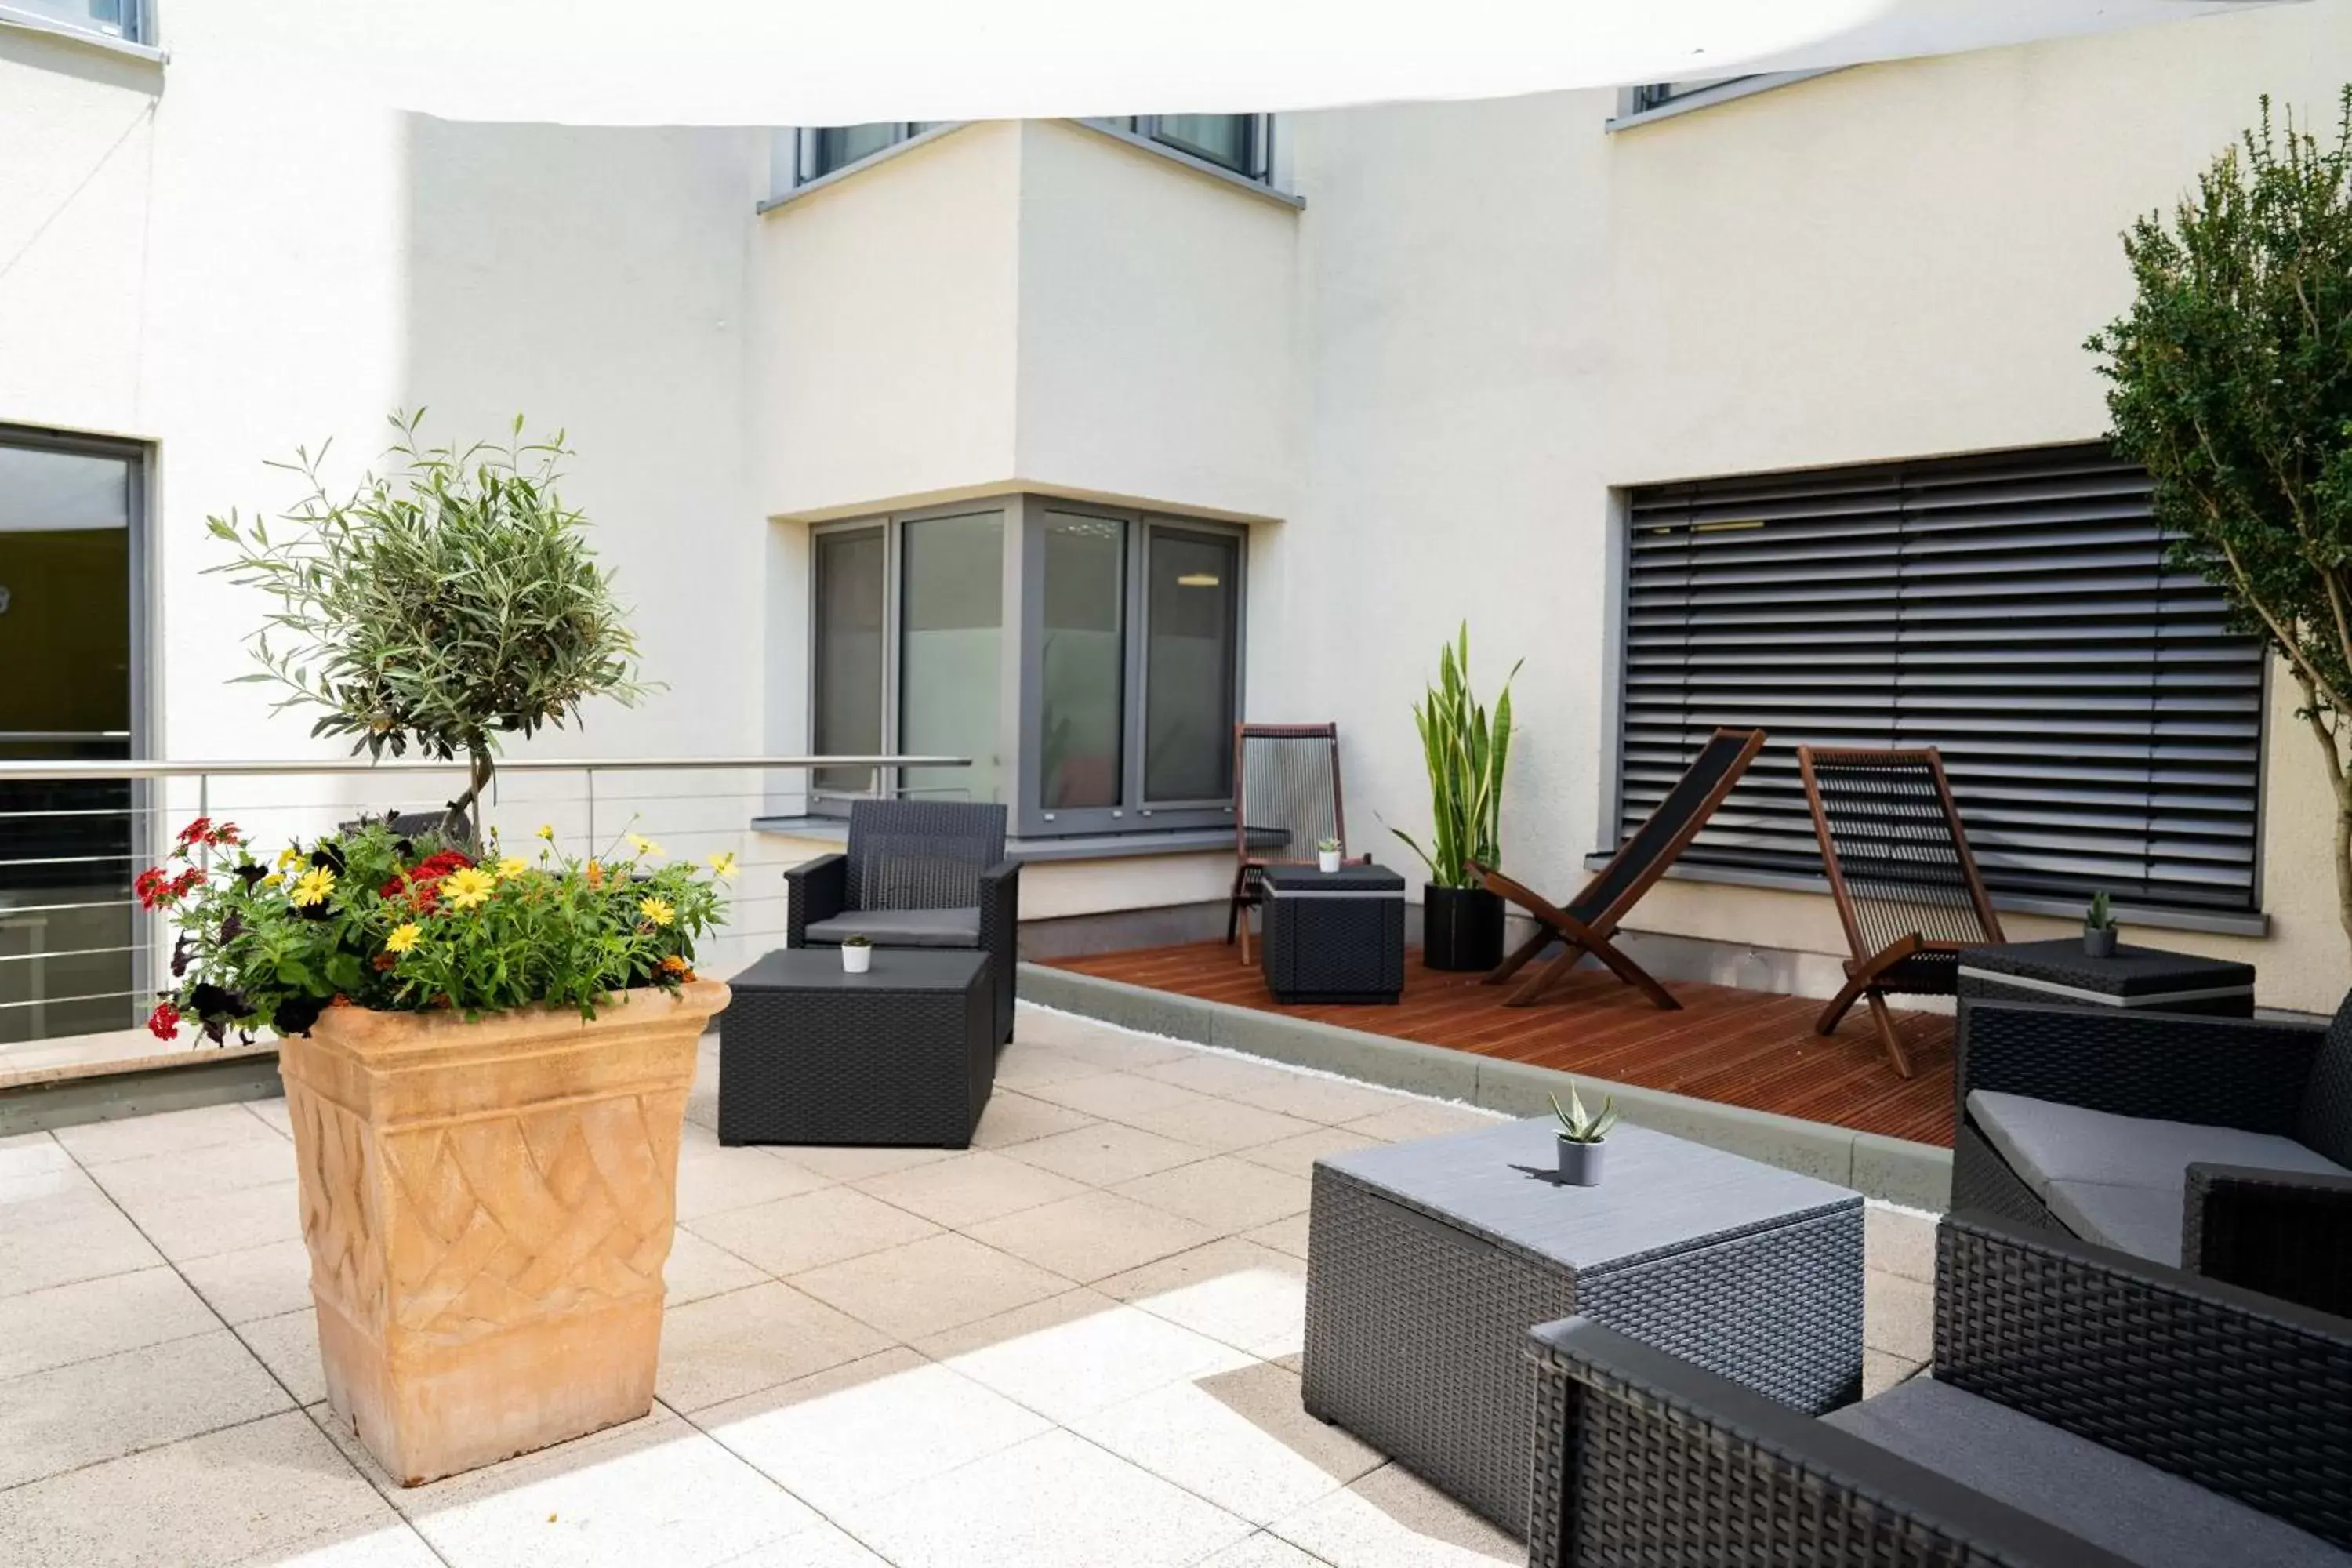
[2089,87,2352,935]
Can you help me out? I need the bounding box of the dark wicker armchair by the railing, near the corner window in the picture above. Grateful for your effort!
[783,799,1021,1044]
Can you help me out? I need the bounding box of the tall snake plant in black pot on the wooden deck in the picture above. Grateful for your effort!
[1390,621,1524,968]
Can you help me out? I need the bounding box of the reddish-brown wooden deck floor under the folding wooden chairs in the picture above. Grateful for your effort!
[1054,942,1952,1147]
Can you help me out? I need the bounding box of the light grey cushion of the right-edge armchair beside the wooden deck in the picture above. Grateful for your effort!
[1969,1088,2347,1201]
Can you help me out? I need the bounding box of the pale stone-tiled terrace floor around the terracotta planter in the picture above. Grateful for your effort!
[0,1008,1933,1568]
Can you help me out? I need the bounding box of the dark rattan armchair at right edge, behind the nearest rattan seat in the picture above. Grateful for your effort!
[1952,996,2352,1314]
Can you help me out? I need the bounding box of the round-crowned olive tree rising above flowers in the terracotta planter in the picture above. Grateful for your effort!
[207,409,647,841]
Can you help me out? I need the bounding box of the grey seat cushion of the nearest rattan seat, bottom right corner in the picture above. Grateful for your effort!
[1823,1377,2352,1568]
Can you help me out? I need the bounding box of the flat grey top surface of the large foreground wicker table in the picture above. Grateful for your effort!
[1315,1116,1863,1274]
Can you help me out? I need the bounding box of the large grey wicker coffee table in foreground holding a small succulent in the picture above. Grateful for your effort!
[1303,1116,1863,1535]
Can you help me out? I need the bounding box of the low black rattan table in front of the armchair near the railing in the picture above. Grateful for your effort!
[720,947,997,1149]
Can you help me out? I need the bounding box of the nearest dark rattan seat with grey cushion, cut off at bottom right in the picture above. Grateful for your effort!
[1529,1215,2352,1568]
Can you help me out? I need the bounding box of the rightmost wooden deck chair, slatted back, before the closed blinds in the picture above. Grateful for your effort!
[1797,746,2009,1076]
